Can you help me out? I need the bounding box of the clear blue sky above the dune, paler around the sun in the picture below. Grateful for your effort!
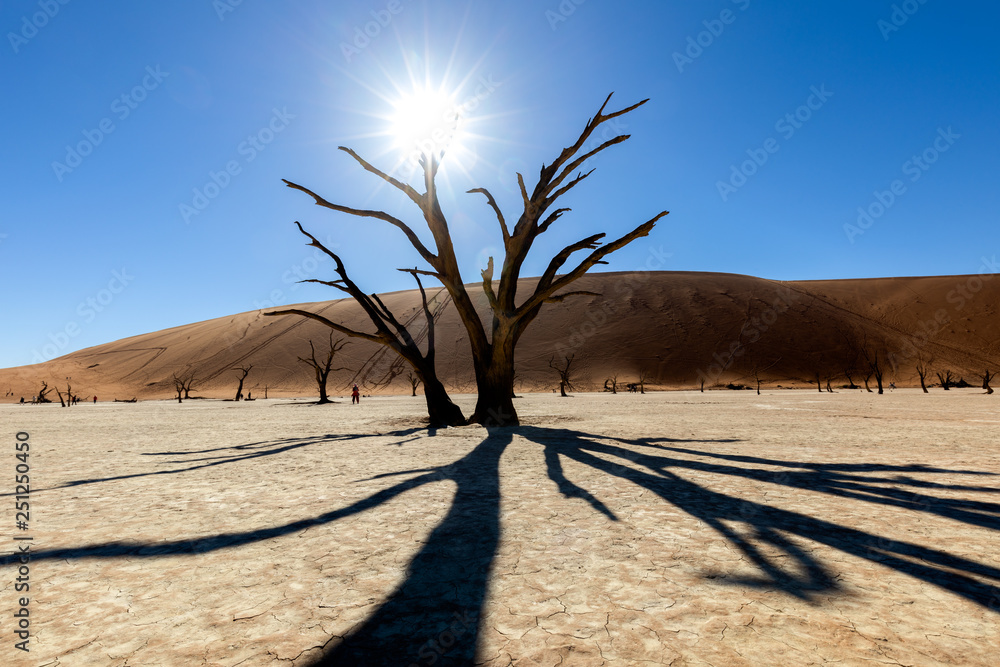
[0,0,1000,366]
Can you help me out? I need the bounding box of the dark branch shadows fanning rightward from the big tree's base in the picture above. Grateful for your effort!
[519,426,1000,611]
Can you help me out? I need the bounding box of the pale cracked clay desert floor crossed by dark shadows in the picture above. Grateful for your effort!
[0,390,1000,667]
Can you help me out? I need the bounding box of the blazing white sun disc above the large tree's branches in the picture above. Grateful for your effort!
[389,89,463,156]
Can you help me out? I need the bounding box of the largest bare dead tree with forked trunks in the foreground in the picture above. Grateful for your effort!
[266,95,667,426]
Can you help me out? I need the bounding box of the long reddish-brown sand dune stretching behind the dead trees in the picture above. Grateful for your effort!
[0,272,1000,402]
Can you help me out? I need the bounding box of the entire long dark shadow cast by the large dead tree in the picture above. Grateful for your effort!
[13,426,1000,667]
